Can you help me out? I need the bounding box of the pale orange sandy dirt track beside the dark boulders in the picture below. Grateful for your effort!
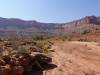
[43,41,100,75]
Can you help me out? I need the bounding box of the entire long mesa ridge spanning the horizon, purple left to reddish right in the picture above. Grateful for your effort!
[0,16,100,35]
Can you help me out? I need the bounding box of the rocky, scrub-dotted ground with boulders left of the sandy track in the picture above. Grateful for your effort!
[0,40,55,75]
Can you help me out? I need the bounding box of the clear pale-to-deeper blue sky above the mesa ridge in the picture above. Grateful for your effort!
[0,0,100,23]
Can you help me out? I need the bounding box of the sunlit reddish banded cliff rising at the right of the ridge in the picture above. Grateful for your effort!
[63,16,100,34]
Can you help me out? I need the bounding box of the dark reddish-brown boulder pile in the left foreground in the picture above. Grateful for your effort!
[0,53,52,75]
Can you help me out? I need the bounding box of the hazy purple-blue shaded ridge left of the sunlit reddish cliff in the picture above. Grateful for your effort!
[0,18,60,35]
